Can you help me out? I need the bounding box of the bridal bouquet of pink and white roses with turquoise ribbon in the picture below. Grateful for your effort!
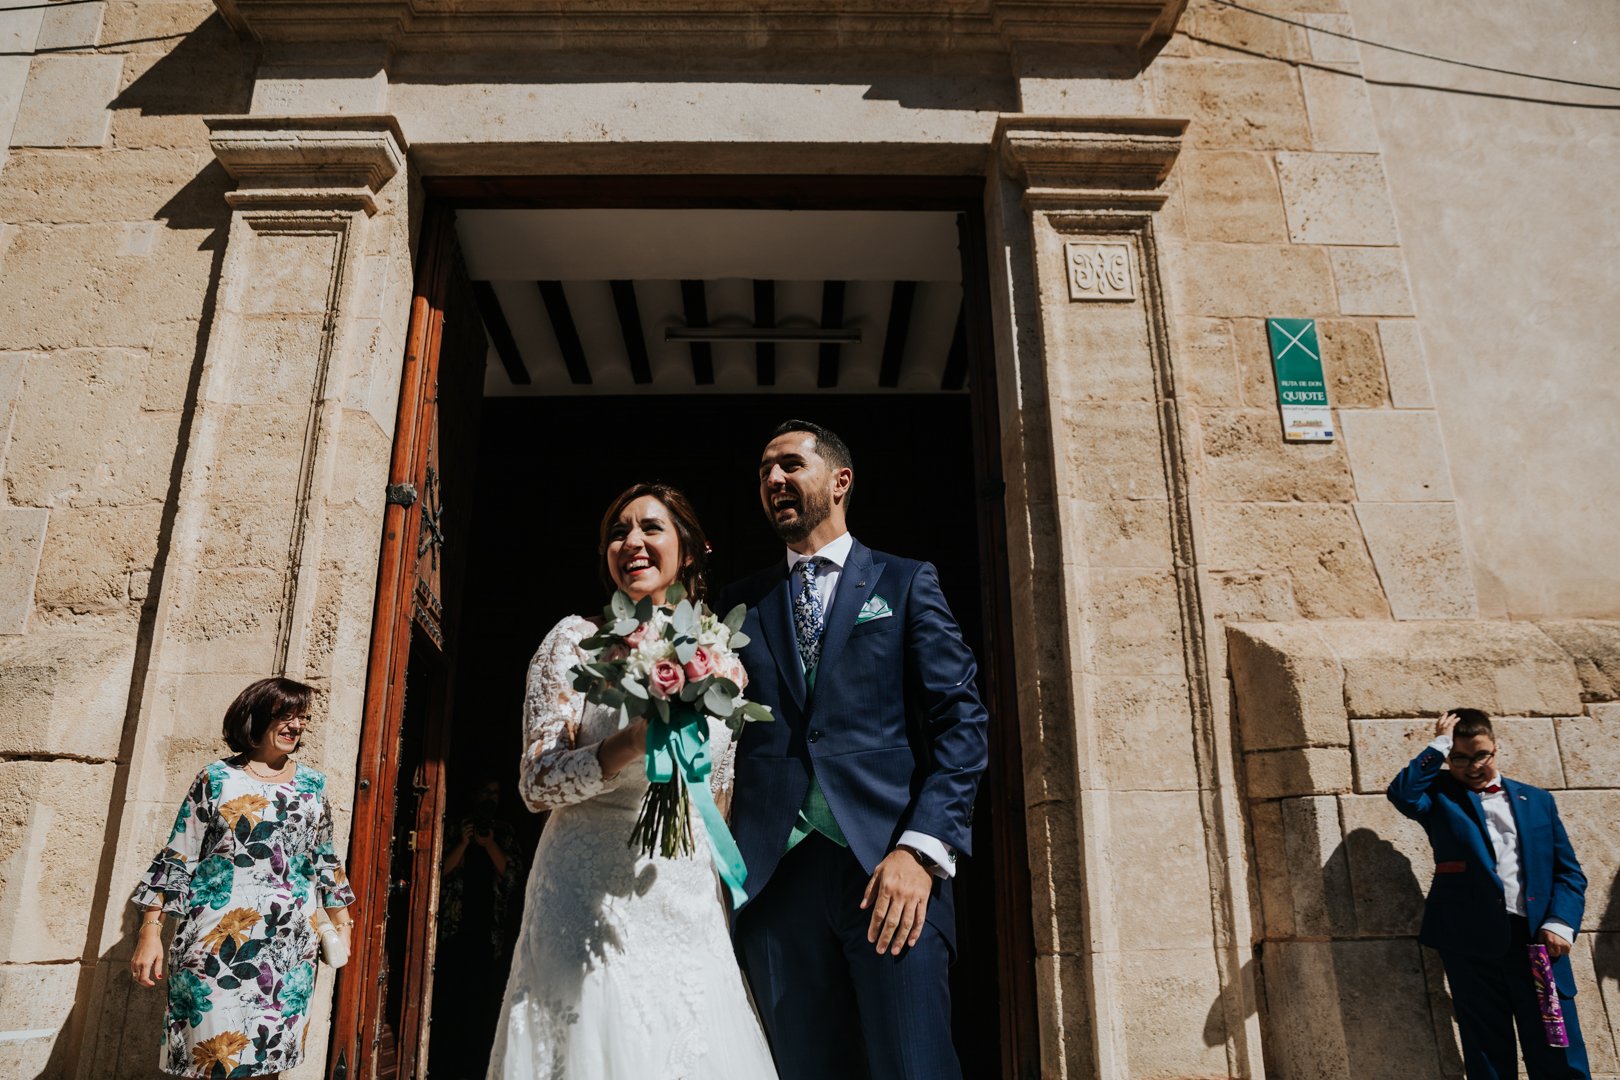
[570,583,773,902]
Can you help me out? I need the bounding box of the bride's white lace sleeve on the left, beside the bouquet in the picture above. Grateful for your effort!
[518,615,617,813]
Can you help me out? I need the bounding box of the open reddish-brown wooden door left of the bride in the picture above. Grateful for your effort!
[327,212,486,1080]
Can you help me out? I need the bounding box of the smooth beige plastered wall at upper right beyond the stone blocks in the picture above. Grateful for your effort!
[1348,0,1620,619]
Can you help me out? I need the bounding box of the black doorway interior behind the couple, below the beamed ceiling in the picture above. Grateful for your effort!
[429,393,1000,1080]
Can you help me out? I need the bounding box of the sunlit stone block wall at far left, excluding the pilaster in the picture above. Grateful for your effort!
[0,2,251,1077]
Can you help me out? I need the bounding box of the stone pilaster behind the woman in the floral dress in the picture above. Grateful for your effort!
[78,115,411,1077]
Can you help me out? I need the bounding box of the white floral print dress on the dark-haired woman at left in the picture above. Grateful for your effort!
[131,759,355,1080]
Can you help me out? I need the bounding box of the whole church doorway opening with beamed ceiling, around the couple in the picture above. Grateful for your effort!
[348,176,1038,1080]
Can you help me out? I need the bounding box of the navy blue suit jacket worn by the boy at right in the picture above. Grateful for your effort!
[1388,746,1586,997]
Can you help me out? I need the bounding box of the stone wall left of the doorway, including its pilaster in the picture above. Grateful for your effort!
[0,2,411,1077]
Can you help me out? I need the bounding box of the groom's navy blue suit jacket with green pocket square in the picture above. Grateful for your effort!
[719,541,988,947]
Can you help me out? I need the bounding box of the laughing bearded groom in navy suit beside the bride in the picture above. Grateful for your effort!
[719,421,988,1080]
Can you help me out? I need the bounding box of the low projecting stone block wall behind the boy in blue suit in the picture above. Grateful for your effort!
[1228,622,1620,1080]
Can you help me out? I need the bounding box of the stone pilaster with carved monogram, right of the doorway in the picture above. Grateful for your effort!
[990,115,1262,1077]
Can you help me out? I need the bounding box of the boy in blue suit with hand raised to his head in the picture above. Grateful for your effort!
[1388,709,1591,1080]
